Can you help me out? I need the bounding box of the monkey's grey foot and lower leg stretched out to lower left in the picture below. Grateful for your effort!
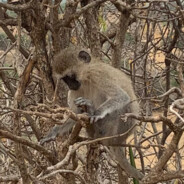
[40,119,75,144]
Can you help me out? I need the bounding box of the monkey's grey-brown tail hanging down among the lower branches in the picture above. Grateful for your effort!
[110,147,144,180]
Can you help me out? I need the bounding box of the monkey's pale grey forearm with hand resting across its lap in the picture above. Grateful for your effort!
[90,89,130,123]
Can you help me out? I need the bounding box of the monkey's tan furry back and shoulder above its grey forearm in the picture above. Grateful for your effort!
[79,61,139,113]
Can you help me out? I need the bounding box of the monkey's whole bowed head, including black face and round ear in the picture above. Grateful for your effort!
[52,48,91,90]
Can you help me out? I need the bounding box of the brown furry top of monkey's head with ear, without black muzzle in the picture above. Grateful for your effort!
[52,47,91,78]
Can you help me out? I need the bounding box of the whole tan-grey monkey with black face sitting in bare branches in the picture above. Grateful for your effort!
[41,47,143,180]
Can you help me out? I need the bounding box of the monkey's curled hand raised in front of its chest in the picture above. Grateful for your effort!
[74,97,95,116]
